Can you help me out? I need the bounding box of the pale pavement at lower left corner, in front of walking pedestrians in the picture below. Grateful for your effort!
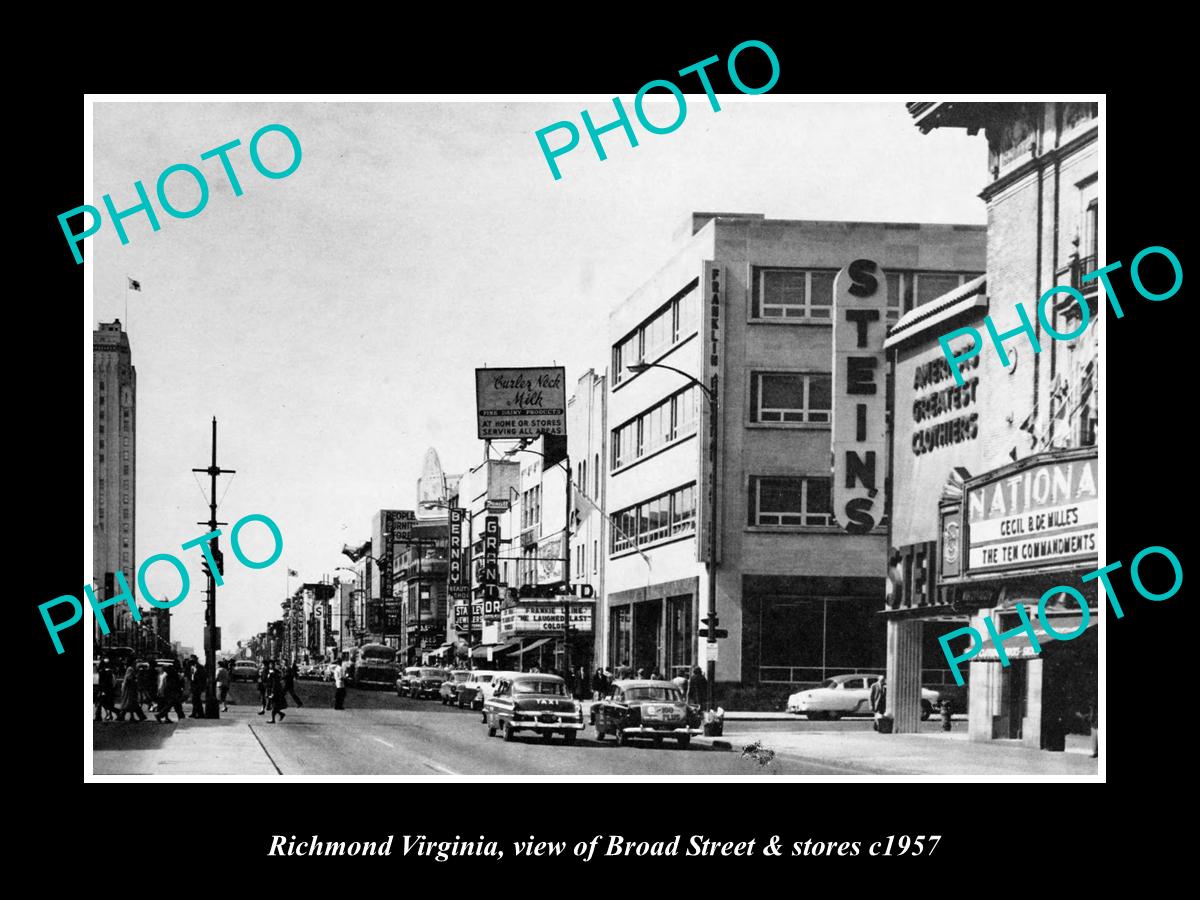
[91,707,280,778]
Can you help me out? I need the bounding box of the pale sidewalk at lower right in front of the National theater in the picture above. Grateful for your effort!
[692,729,1098,775]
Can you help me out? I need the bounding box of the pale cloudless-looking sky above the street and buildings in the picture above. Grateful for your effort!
[85,95,986,649]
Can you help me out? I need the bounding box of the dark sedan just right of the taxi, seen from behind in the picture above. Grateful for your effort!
[594,679,702,748]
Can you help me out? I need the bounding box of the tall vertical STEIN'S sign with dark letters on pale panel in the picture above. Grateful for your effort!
[830,259,888,534]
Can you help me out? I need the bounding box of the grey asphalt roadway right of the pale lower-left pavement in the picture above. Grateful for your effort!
[223,682,870,776]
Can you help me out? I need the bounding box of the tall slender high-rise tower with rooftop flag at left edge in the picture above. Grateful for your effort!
[91,319,156,647]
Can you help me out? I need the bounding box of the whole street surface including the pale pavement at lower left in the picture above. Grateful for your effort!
[94,682,965,776]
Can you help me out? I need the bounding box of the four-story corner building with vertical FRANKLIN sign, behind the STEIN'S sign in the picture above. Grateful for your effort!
[602,214,984,703]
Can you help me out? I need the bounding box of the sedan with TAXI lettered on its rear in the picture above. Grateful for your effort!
[484,672,584,744]
